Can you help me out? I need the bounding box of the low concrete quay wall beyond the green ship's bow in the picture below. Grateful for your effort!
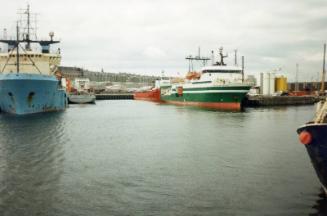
[244,95,321,107]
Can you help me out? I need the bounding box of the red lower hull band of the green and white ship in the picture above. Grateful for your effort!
[165,101,241,111]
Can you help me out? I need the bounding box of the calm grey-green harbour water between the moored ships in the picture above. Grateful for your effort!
[0,101,326,215]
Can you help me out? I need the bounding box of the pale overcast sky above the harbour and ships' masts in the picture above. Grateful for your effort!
[0,0,327,81]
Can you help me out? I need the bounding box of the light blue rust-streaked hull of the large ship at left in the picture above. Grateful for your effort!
[0,73,67,115]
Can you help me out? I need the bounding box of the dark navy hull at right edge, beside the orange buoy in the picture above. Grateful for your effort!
[297,123,327,193]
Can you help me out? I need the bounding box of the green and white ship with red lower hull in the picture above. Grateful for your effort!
[161,48,251,111]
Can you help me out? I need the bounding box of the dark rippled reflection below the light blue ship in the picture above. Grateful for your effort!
[0,113,65,215]
